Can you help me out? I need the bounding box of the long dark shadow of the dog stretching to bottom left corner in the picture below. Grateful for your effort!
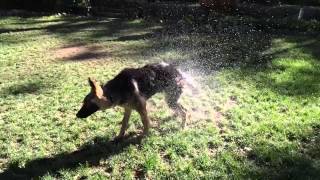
[0,133,143,179]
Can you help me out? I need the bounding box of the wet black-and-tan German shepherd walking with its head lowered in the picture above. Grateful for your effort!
[77,62,186,138]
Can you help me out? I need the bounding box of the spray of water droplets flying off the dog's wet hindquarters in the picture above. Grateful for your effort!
[138,8,270,126]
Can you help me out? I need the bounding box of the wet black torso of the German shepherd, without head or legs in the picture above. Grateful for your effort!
[103,63,182,105]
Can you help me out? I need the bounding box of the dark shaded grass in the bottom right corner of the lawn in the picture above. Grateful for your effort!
[248,125,320,179]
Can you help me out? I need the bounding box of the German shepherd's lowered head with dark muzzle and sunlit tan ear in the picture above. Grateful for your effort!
[77,78,112,118]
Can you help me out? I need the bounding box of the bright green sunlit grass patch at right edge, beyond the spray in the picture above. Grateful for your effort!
[235,35,320,97]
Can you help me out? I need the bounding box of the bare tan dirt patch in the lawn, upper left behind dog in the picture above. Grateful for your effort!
[54,44,111,61]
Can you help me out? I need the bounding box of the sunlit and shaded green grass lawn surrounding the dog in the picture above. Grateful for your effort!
[0,16,320,179]
